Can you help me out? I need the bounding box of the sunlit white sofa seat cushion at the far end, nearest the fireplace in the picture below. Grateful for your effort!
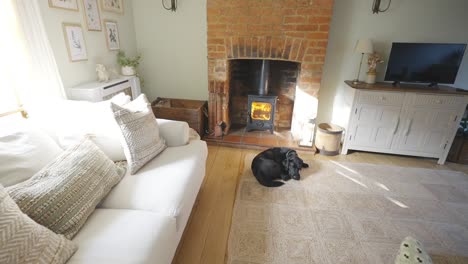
[98,140,208,228]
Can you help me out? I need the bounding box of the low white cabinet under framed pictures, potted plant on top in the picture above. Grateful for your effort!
[67,76,141,102]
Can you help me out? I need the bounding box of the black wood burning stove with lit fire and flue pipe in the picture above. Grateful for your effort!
[246,60,277,134]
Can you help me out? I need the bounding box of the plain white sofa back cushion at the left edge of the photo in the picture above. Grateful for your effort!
[0,117,63,186]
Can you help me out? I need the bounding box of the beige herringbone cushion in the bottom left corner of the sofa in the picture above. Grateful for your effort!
[0,185,77,264]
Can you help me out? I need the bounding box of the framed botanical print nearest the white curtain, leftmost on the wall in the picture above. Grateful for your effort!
[62,23,88,62]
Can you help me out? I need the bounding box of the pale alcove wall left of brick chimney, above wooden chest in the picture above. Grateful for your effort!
[133,0,208,100]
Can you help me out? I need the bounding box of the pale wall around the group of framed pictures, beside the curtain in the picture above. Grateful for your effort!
[36,0,136,88]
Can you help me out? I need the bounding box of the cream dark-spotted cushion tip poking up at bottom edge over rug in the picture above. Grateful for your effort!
[395,237,432,264]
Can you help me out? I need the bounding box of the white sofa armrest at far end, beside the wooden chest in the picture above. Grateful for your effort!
[157,118,190,147]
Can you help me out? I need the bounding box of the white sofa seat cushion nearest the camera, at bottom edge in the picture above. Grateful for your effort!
[68,209,177,264]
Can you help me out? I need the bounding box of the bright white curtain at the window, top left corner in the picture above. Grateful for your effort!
[0,0,65,113]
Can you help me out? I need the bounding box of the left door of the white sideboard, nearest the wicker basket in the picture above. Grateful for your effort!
[350,104,401,149]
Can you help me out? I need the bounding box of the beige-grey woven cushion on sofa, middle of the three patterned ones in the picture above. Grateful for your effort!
[7,138,125,238]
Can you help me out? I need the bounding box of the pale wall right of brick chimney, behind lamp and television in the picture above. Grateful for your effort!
[318,0,468,128]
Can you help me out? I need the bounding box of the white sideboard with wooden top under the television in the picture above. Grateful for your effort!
[342,81,468,164]
